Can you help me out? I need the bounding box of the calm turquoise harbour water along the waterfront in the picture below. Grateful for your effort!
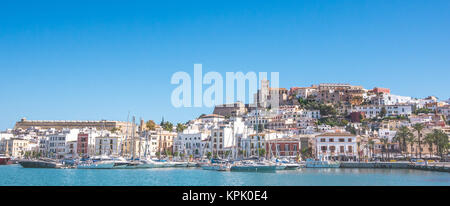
[0,165,450,186]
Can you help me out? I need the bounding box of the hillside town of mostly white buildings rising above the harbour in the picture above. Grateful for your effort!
[0,80,450,166]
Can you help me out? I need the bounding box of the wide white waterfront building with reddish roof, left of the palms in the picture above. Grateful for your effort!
[315,133,358,161]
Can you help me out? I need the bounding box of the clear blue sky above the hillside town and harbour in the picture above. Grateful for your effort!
[0,0,450,129]
